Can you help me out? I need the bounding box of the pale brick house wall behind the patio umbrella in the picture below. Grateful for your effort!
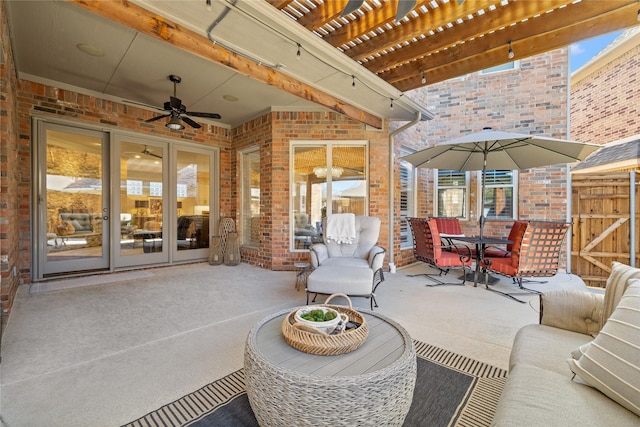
[395,48,569,265]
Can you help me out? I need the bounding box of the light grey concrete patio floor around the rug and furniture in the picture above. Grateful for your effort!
[0,263,585,427]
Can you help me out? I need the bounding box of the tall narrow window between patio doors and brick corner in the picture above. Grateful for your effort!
[240,147,260,246]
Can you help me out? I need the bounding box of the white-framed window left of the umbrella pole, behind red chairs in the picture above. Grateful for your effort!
[435,170,469,218]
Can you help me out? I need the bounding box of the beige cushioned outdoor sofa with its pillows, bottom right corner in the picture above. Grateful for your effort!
[493,262,640,427]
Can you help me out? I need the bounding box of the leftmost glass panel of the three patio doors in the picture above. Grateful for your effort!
[35,123,110,278]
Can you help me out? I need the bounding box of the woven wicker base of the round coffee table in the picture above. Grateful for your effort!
[244,310,417,427]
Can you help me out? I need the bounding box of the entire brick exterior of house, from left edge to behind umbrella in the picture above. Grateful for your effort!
[0,37,567,318]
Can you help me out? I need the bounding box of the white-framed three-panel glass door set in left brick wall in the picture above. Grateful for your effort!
[32,119,219,280]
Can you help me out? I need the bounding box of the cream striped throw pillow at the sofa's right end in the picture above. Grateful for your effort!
[567,279,640,415]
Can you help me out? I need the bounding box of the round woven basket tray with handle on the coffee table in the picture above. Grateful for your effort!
[282,294,369,356]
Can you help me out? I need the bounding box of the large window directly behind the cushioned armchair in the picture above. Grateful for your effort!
[290,141,368,250]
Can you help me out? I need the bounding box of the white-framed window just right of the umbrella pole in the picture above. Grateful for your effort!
[480,170,517,219]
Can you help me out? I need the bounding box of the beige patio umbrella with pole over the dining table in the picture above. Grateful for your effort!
[402,128,600,238]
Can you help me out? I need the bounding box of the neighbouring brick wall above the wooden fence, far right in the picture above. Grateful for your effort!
[571,44,640,144]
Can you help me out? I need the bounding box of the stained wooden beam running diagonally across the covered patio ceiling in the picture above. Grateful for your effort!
[67,0,382,129]
